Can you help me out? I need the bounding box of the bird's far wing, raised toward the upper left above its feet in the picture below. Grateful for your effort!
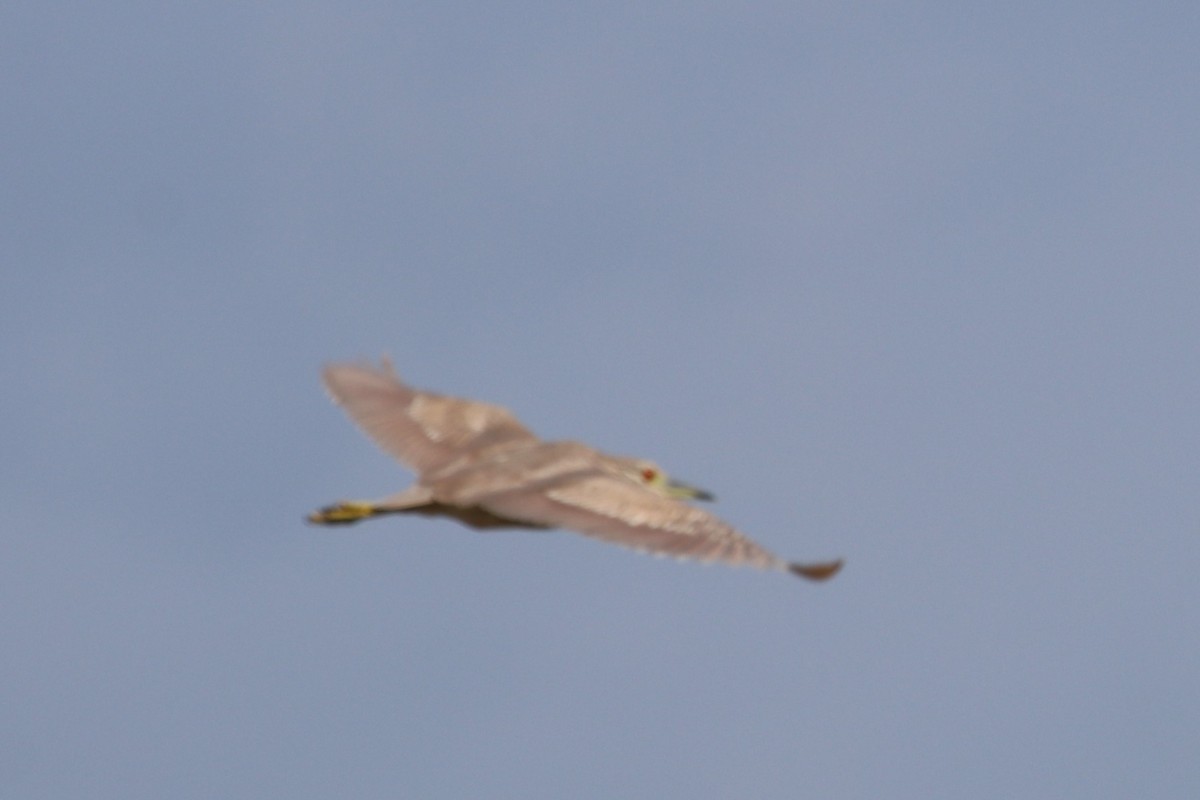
[322,362,538,473]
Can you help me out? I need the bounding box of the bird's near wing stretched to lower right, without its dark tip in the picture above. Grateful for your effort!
[479,470,788,569]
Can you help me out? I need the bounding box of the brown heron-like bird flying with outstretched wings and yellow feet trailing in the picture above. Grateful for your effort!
[307,359,842,581]
